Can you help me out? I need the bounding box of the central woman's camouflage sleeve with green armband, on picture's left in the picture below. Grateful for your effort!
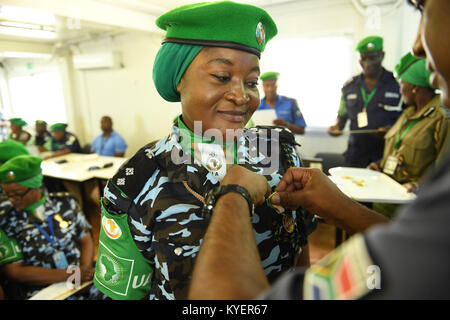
[94,143,156,300]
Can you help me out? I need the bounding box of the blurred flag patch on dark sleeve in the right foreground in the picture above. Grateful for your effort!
[303,234,374,300]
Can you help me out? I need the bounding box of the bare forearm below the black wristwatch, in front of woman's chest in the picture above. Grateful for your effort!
[188,192,269,299]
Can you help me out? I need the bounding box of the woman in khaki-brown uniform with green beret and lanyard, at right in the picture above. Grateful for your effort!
[369,53,449,216]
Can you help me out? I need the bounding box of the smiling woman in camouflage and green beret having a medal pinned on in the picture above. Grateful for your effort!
[94,1,317,299]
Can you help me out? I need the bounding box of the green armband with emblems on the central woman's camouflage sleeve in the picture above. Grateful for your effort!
[94,198,153,300]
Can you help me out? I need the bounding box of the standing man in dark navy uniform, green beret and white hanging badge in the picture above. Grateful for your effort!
[328,36,402,168]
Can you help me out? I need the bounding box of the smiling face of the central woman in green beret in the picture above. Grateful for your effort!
[177,47,260,138]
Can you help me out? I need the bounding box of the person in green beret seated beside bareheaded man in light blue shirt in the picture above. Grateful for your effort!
[44,123,81,159]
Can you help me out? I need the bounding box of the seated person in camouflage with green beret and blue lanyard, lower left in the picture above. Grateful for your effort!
[0,155,94,299]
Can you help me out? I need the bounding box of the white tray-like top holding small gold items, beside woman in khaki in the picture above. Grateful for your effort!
[328,167,416,203]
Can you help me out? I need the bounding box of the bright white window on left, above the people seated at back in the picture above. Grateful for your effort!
[8,71,67,129]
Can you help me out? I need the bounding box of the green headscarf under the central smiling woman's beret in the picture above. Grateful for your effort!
[153,42,203,102]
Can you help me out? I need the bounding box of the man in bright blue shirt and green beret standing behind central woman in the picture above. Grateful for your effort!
[258,71,306,134]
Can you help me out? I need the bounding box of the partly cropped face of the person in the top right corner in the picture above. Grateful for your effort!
[413,0,450,108]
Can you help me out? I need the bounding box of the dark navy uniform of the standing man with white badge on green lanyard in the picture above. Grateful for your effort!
[338,69,402,168]
